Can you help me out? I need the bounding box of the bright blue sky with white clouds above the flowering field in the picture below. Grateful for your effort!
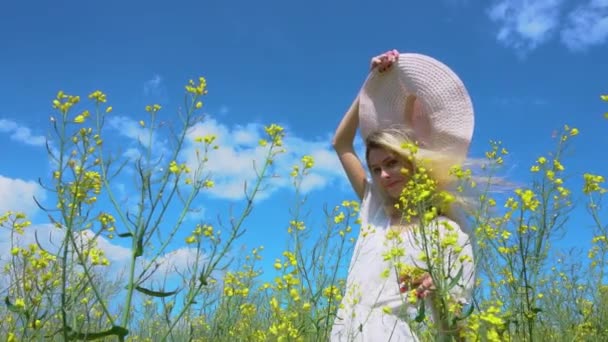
[0,0,608,284]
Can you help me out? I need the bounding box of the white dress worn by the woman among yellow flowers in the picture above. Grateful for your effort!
[331,181,474,342]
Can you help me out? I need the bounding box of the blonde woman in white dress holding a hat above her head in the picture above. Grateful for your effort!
[331,50,474,342]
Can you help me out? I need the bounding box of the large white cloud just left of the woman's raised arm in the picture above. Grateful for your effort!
[183,116,345,199]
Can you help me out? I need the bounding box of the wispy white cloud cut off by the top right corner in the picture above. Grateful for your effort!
[561,0,608,51]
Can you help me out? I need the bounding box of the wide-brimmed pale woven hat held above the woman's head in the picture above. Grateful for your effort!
[359,53,474,158]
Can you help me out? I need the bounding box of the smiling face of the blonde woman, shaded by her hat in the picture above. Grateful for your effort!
[368,148,412,199]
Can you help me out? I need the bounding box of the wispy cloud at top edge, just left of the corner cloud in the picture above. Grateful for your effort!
[488,0,564,53]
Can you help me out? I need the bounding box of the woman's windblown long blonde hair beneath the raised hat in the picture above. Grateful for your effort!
[365,126,475,228]
